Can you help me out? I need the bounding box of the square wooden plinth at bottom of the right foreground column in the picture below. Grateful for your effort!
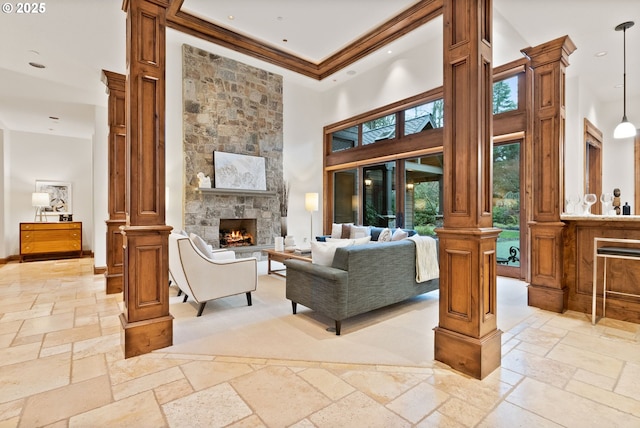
[434,327,502,379]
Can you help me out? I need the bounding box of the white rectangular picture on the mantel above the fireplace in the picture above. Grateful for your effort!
[213,151,267,190]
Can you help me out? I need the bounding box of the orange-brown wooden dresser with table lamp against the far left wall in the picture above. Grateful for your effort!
[20,221,82,262]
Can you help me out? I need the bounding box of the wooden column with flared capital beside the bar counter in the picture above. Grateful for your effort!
[522,36,576,312]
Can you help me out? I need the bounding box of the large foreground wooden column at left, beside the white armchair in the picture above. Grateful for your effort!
[120,0,173,358]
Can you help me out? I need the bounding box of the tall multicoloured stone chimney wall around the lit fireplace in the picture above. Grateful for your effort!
[182,45,283,257]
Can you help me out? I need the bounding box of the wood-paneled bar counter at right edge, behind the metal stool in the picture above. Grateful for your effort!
[561,215,640,323]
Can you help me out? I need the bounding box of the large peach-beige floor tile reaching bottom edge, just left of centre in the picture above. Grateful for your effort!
[230,366,330,427]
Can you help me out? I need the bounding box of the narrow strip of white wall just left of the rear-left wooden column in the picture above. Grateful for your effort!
[91,107,109,268]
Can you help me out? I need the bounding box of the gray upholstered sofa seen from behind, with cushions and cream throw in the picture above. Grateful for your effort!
[284,239,439,335]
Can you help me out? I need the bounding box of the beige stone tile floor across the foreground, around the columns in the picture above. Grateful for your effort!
[0,258,640,428]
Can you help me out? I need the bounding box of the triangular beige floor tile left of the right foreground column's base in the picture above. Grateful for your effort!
[340,370,429,404]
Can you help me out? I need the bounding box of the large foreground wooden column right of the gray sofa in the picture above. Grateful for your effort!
[435,0,502,379]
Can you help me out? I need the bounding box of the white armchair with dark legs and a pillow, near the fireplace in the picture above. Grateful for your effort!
[169,233,258,316]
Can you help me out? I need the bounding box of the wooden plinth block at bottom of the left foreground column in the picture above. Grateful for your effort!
[120,313,173,358]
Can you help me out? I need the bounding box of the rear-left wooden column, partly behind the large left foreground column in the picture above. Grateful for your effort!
[102,70,127,294]
